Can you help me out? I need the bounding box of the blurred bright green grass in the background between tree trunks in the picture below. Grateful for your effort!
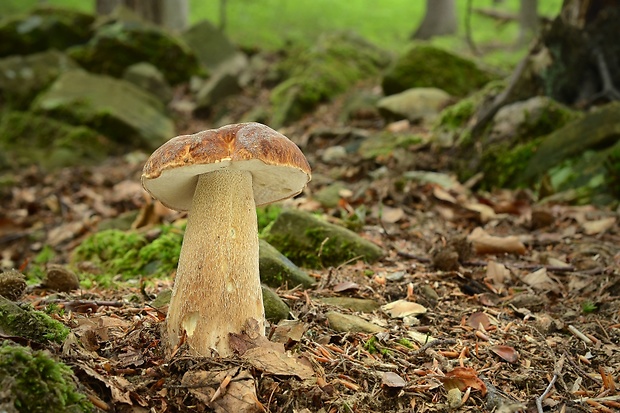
[0,0,562,66]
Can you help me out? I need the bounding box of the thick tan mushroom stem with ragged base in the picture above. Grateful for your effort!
[167,170,265,357]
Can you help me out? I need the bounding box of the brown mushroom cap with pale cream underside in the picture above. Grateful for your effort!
[142,122,311,211]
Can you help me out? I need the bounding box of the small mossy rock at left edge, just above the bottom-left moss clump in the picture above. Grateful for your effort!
[0,296,69,343]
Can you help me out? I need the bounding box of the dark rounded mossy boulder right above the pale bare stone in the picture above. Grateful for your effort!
[382,45,492,96]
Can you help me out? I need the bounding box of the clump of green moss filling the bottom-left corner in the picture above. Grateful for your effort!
[0,342,93,413]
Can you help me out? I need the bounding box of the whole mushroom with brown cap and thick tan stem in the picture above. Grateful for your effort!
[142,123,311,356]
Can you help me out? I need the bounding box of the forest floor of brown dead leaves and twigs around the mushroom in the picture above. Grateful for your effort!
[0,87,620,412]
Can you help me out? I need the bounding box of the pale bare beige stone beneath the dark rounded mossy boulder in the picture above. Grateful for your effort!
[377,87,451,122]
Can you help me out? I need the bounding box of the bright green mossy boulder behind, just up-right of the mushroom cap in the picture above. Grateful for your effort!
[271,32,390,126]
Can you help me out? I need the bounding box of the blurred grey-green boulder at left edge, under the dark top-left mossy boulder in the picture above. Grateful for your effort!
[0,50,78,109]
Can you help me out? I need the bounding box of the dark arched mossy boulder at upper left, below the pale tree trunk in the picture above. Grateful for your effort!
[67,21,203,85]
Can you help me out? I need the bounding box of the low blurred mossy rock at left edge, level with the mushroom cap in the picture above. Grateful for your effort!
[0,111,110,169]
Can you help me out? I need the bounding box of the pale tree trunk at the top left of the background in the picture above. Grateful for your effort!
[95,0,189,31]
